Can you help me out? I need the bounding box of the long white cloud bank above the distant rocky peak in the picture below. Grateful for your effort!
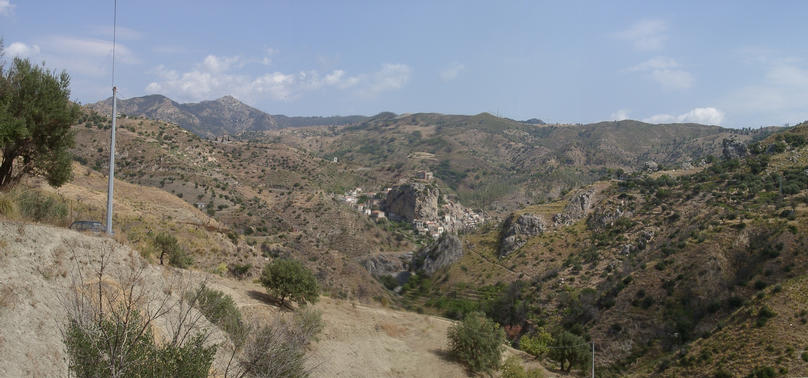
[146,55,410,101]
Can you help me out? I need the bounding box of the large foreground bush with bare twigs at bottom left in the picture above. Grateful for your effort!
[62,258,217,377]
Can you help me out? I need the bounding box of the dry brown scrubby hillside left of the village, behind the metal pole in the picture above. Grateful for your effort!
[69,112,415,298]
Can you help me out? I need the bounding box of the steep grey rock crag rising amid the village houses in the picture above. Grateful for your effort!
[382,183,440,222]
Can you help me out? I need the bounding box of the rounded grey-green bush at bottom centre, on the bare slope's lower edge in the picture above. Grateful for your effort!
[448,312,505,372]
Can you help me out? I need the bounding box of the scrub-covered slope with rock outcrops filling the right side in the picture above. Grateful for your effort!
[396,120,808,377]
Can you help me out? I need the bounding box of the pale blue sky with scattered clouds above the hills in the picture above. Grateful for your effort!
[0,0,808,128]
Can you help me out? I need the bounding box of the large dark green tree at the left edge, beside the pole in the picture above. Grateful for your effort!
[0,51,80,189]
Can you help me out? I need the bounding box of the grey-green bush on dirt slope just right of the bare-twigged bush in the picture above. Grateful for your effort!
[186,283,244,335]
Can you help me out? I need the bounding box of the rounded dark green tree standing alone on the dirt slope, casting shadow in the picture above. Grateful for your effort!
[261,259,320,304]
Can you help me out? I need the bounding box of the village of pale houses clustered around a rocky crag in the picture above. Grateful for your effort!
[338,171,485,239]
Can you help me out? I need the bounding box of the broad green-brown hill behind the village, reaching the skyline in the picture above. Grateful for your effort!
[260,113,768,212]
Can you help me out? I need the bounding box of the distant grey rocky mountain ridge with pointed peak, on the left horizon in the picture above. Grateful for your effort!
[87,95,368,137]
